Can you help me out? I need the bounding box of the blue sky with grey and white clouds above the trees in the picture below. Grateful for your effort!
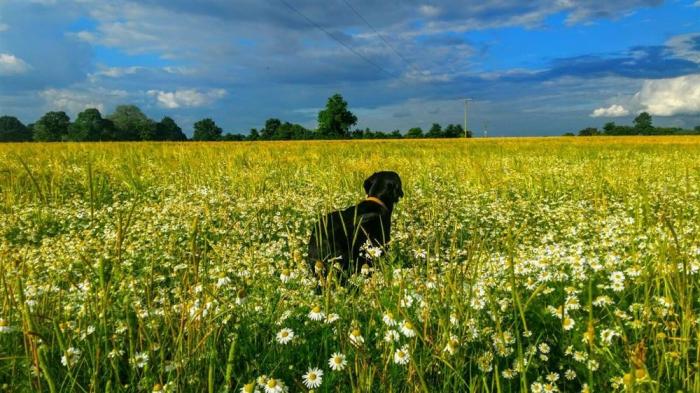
[0,0,700,136]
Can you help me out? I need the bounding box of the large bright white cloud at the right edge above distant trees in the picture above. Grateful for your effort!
[634,74,700,116]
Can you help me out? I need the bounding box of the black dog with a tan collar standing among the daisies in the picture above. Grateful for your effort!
[308,172,403,285]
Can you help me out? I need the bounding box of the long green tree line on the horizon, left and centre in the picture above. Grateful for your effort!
[0,94,472,142]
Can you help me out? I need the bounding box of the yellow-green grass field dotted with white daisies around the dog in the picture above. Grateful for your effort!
[0,137,700,393]
